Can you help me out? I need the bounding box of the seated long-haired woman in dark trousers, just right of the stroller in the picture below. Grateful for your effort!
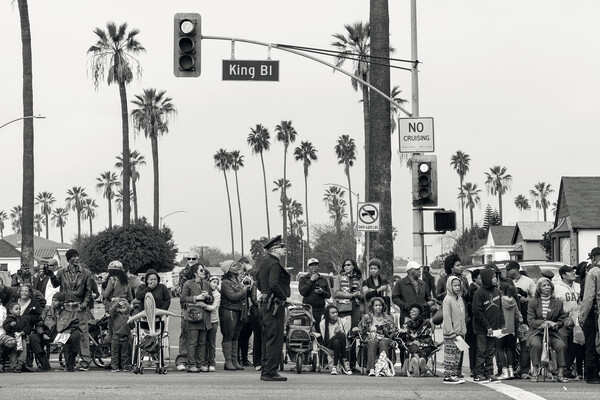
[320,304,352,375]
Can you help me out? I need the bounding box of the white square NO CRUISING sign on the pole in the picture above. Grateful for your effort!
[398,117,435,153]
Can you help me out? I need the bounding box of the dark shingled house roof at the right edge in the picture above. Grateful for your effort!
[554,176,600,229]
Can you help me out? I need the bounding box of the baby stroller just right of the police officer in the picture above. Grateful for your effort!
[279,304,319,374]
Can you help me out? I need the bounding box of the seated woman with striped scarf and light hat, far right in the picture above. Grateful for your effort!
[527,278,568,383]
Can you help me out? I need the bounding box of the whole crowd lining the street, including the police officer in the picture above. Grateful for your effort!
[0,236,600,384]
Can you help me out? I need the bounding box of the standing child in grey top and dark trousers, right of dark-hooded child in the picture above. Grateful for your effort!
[496,283,523,379]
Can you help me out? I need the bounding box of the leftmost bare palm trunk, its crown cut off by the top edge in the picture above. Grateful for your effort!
[17,0,35,265]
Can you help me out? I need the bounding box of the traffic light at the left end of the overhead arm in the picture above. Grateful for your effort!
[173,13,202,77]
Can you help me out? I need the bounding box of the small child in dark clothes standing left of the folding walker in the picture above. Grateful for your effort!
[110,299,131,372]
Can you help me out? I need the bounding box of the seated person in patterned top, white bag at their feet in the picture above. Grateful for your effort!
[358,297,398,376]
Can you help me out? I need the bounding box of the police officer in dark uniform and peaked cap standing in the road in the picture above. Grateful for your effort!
[257,235,290,381]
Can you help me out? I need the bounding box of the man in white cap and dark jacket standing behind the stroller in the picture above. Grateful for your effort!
[298,258,331,333]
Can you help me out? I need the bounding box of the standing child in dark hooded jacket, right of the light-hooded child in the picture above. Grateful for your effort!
[472,268,504,383]
